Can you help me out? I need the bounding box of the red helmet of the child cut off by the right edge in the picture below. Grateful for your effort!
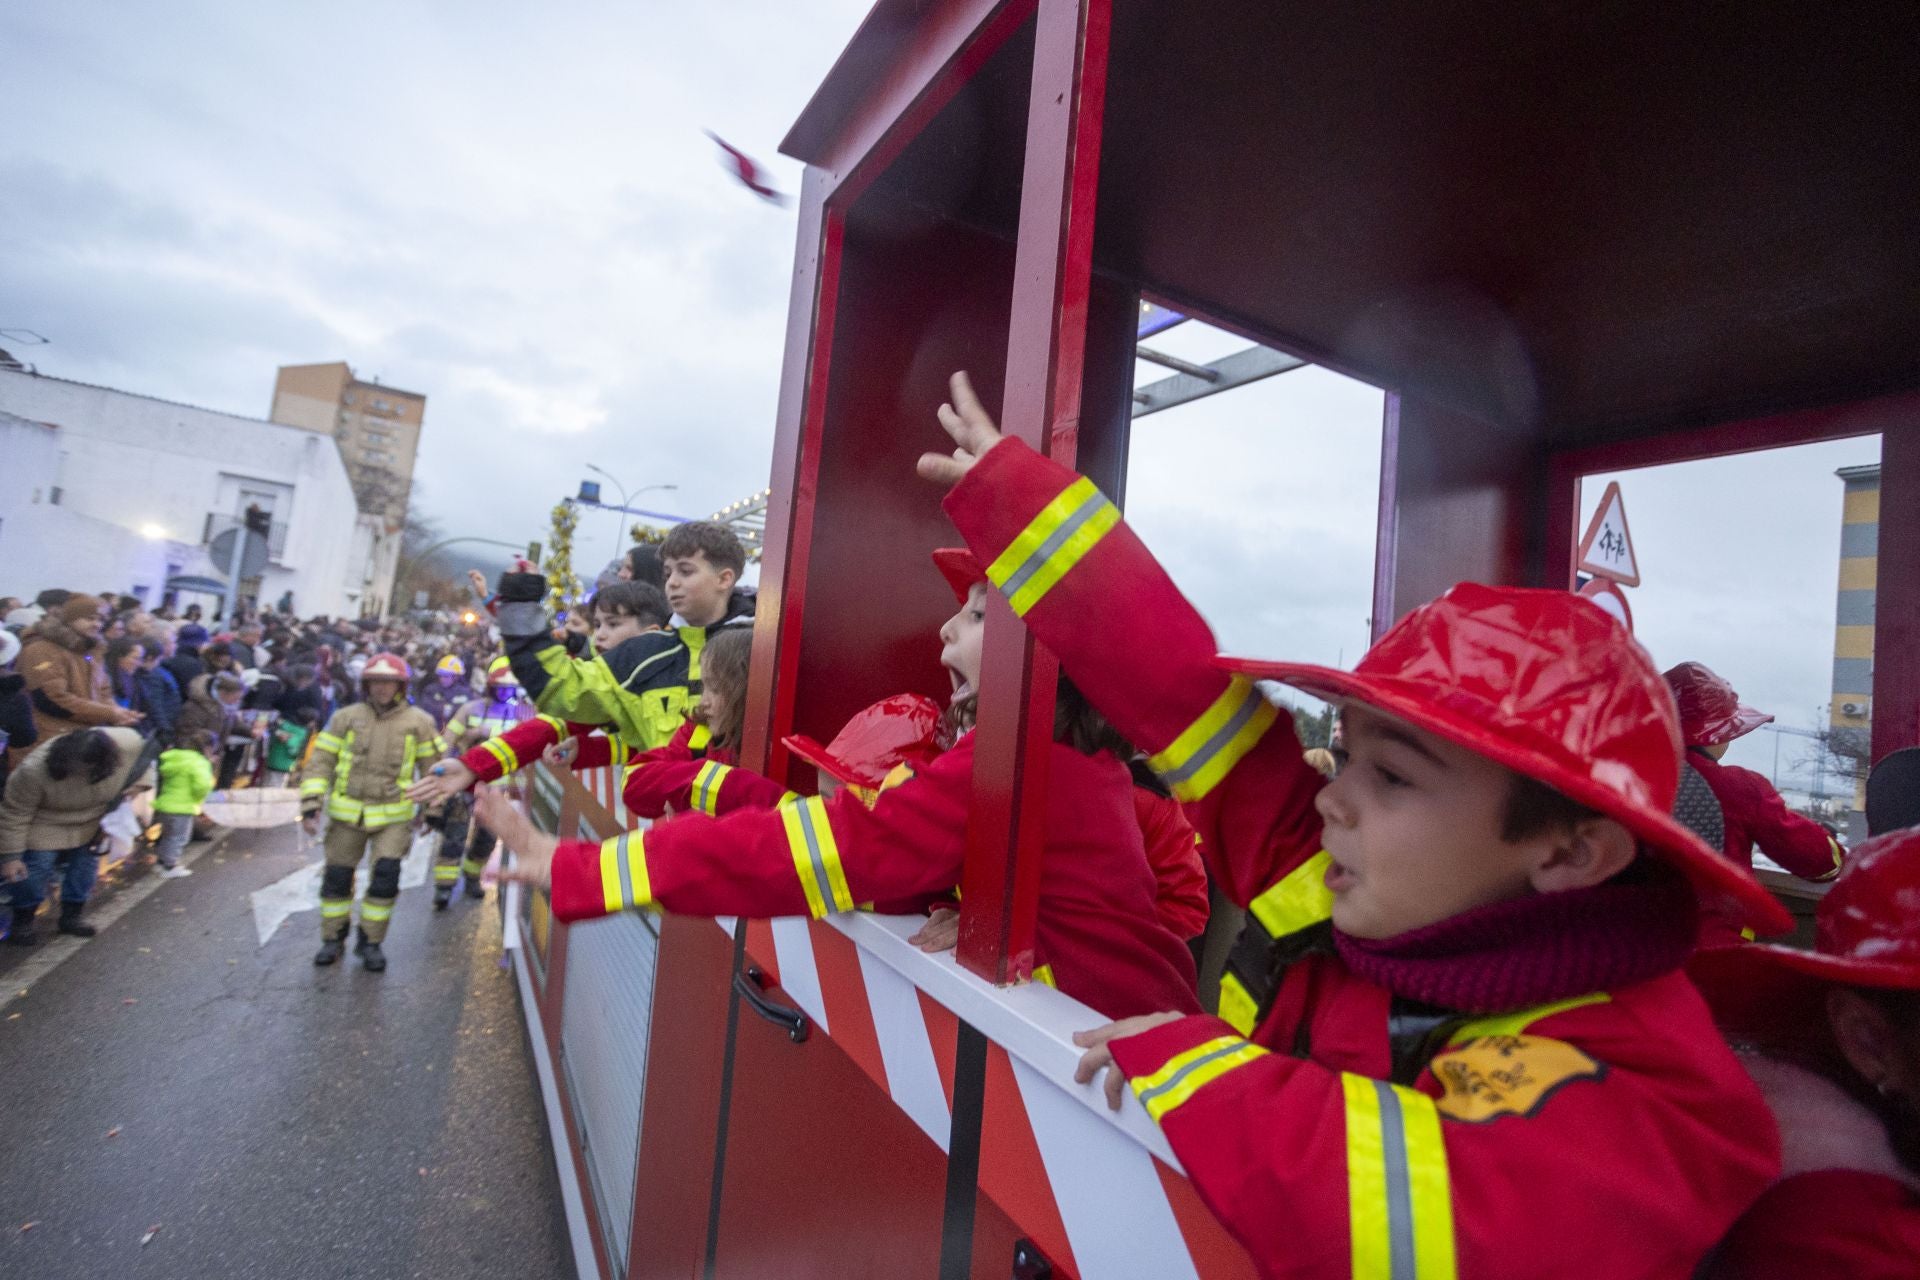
[1688,827,1920,1057]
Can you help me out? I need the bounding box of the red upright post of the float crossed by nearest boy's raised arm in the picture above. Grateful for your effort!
[958,0,1112,983]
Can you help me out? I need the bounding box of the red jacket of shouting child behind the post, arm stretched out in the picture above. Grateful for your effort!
[553,733,1198,1017]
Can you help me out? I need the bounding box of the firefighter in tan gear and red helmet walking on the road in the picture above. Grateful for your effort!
[300,652,447,973]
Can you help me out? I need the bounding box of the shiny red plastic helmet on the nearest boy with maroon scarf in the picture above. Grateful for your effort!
[1215,581,1793,933]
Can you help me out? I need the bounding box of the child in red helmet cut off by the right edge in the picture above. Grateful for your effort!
[1690,827,1920,1280]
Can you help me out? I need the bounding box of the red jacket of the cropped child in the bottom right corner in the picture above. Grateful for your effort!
[1701,1169,1920,1280]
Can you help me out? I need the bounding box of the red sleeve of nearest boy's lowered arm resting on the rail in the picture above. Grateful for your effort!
[1112,1013,1780,1280]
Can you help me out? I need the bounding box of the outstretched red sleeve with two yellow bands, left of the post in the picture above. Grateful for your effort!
[553,750,973,921]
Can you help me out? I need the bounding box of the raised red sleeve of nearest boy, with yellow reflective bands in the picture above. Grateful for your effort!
[947,438,1321,906]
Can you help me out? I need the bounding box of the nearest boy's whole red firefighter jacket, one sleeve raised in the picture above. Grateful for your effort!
[947,439,1780,1280]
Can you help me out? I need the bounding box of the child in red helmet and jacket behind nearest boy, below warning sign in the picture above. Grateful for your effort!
[1663,662,1845,946]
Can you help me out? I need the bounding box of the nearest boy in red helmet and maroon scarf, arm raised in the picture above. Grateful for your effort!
[920,374,1789,1280]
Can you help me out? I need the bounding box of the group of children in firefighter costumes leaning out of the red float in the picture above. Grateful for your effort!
[385,376,1920,1278]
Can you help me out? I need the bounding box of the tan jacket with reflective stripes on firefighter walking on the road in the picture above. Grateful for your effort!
[300,702,447,831]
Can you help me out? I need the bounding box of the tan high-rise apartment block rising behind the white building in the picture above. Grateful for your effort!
[267,361,426,530]
